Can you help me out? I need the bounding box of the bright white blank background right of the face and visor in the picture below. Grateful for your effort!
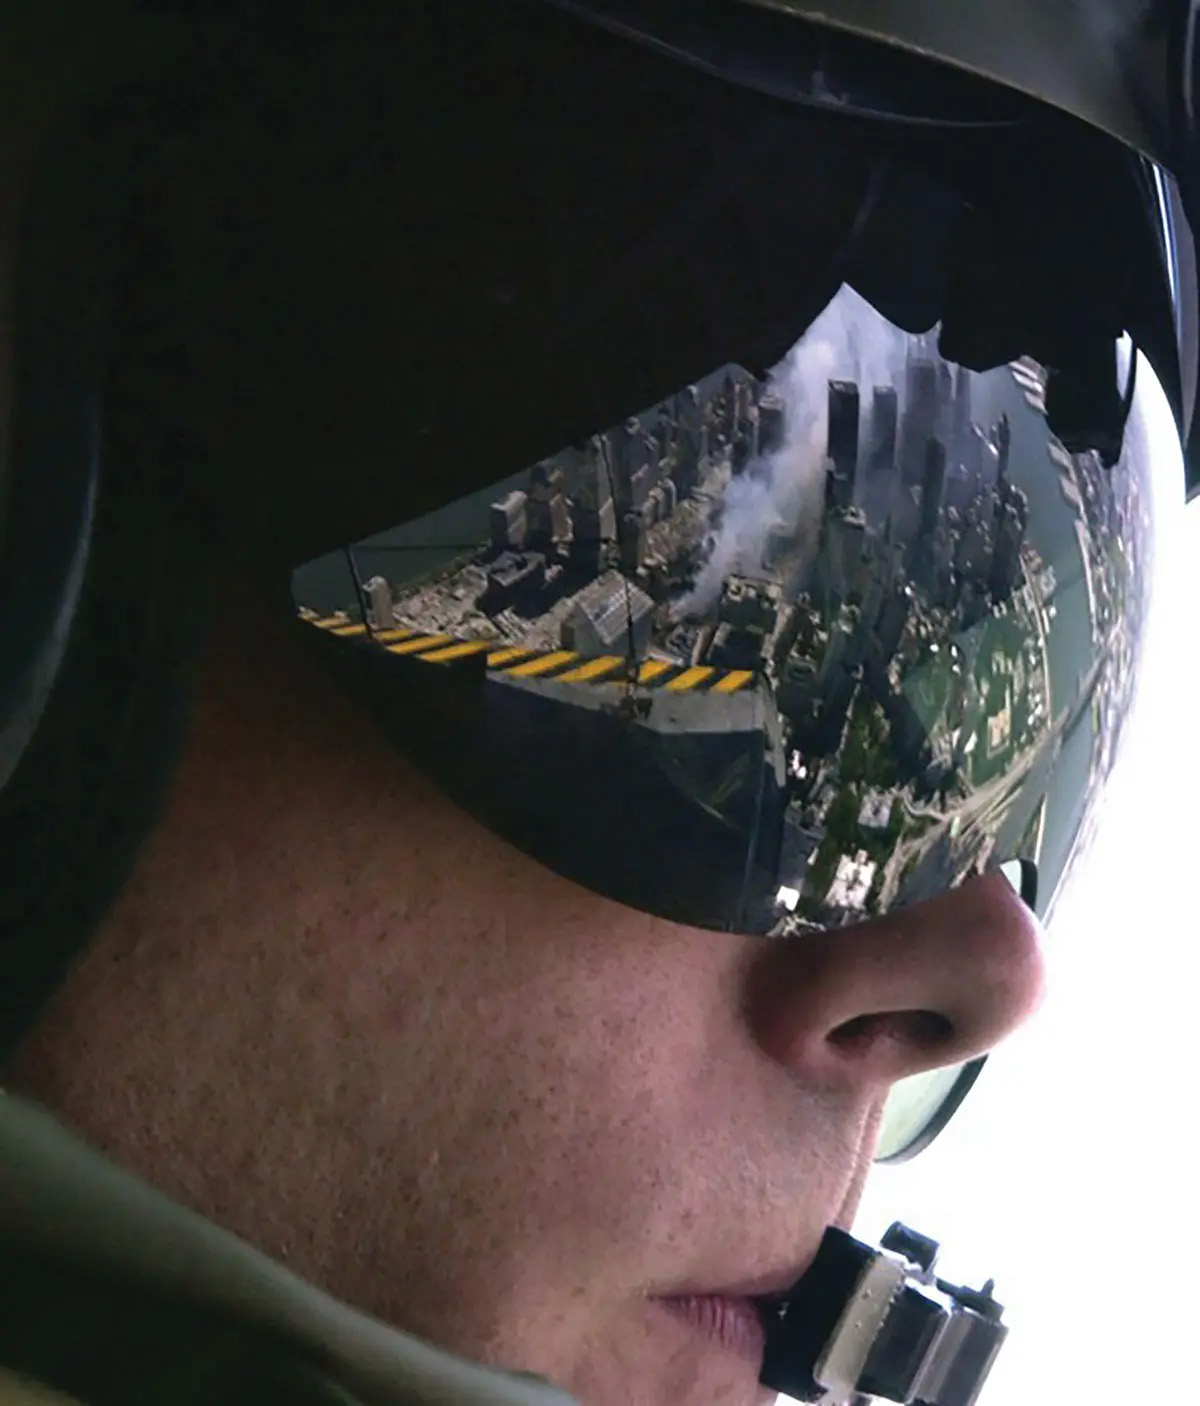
[857,474,1200,1406]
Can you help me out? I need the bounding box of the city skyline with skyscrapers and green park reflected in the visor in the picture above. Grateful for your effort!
[296,298,1137,928]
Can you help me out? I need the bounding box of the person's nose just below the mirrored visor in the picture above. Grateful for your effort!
[744,873,1044,1094]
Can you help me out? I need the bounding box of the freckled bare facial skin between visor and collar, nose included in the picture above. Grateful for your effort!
[4,565,1041,1406]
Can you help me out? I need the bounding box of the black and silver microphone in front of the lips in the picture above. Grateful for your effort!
[760,1220,1009,1406]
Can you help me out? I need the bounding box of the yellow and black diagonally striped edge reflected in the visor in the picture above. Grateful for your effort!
[300,610,755,693]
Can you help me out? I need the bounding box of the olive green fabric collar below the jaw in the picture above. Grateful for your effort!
[0,1091,574,1406]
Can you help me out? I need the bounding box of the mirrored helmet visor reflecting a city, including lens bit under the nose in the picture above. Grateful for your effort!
[294,290,1152,1156]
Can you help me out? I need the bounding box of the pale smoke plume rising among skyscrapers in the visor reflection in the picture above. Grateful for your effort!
[677,288,907,616]
